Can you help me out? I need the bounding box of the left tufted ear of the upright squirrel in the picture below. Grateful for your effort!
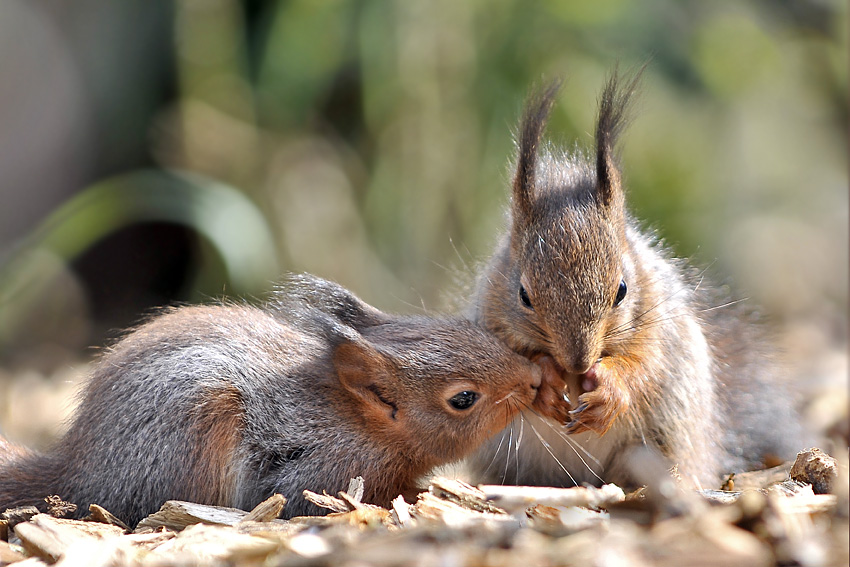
[512,79,562,224]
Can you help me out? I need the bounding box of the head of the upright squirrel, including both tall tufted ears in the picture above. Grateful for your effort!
[490,74,639,374]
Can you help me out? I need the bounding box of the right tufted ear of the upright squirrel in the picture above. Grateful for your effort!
[596,65,646,211]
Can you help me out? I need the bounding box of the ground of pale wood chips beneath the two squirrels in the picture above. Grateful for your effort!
[0,450,850,567]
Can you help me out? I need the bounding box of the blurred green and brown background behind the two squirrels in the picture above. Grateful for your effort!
[0,0,848,444]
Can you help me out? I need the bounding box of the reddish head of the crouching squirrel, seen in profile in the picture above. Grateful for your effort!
[332,317,541,464]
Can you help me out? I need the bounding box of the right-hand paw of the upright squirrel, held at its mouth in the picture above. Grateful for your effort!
[567,364,629,435]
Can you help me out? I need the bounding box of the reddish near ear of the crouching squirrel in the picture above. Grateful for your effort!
[333,339,398,421]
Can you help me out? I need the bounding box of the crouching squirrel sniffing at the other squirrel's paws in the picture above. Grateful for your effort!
[0,275,544,525]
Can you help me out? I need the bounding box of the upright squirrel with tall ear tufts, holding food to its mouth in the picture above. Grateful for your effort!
[467,69,804,487]
